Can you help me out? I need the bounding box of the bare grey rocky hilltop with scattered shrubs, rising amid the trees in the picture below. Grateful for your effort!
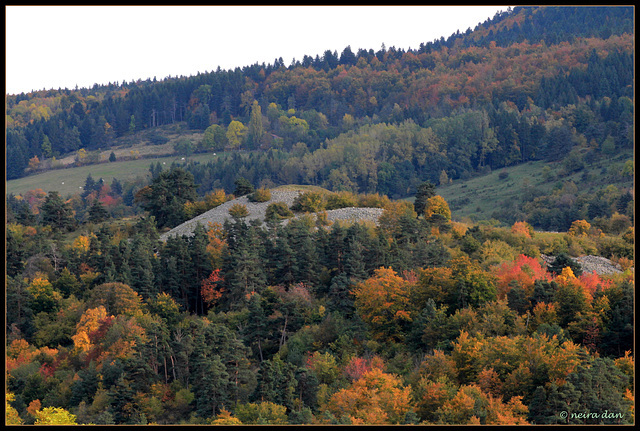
[160,190,383,241]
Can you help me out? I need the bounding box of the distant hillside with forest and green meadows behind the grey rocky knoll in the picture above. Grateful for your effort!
[6,7,634,236]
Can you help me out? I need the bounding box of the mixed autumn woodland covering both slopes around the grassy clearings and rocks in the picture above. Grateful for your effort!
[5,7,635,425]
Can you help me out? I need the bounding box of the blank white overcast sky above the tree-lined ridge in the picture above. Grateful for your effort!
[5,6,508,94]
